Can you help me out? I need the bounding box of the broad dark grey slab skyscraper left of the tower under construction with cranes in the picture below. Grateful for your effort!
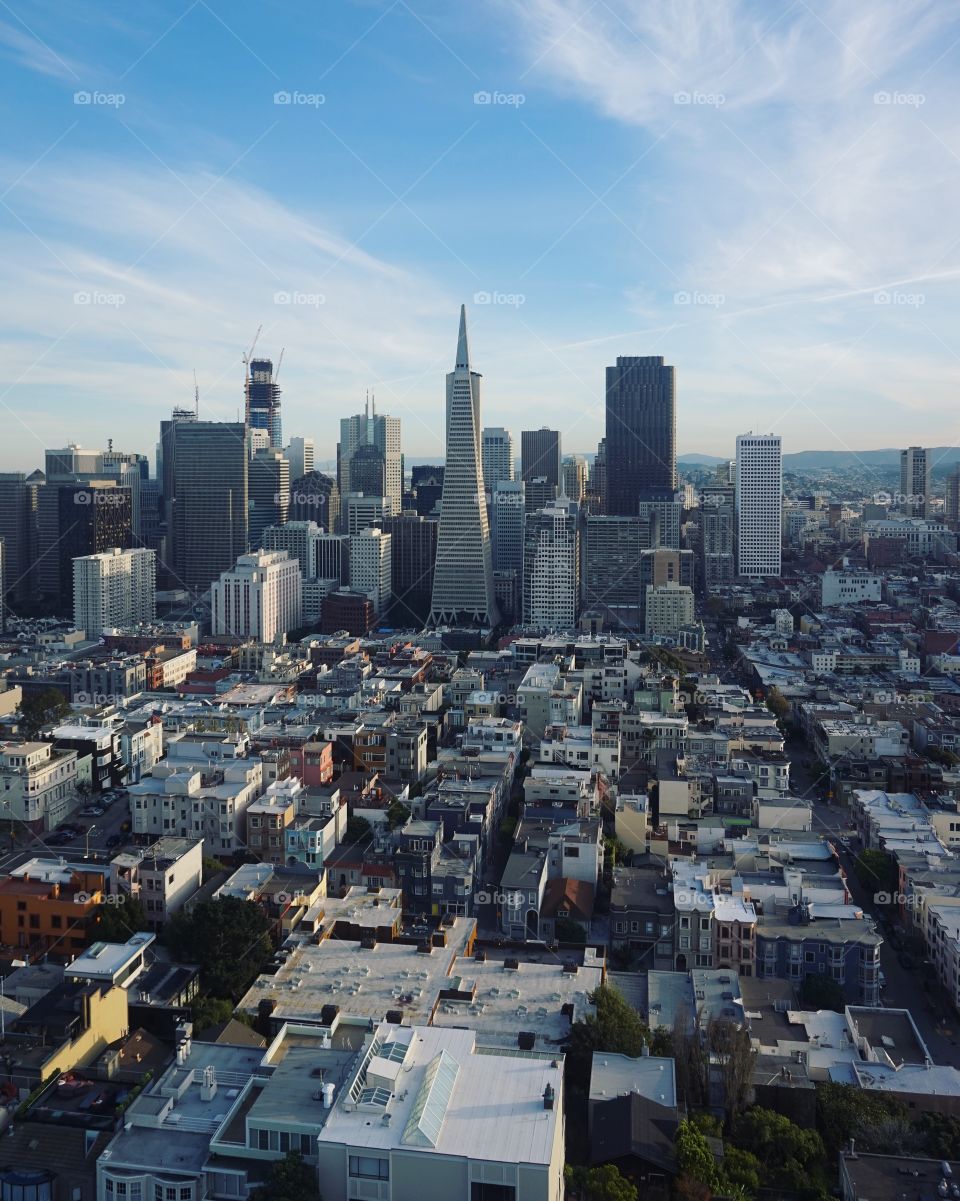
[173,422,250,592]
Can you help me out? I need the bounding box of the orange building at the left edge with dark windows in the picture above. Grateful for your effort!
[0,859,103,958]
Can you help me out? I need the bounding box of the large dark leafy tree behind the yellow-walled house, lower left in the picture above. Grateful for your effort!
[162,897,273,1002]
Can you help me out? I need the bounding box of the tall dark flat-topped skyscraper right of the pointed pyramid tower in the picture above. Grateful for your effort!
[606,354,676,516]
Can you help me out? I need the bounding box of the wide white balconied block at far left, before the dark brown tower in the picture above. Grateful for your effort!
[73,546,156,638]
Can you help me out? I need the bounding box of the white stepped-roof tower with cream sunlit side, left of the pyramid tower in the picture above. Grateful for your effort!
[210,550,303,643]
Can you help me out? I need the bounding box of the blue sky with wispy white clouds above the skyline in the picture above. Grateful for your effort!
[0,0,960,470]
